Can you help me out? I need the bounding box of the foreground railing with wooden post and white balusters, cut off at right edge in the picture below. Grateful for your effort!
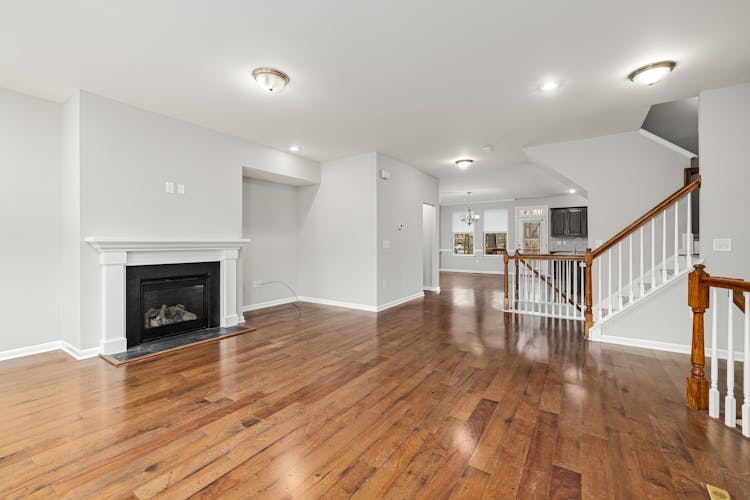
[687,264,750,437]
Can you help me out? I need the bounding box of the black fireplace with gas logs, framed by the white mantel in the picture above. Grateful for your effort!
[125,262,220,347]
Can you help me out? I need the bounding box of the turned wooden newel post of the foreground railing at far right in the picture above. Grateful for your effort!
[687,264,710,410]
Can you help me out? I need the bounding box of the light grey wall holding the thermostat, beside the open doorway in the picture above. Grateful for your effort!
[372,153,438,306]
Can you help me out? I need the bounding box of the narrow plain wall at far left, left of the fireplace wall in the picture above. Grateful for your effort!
[0,89,62,351]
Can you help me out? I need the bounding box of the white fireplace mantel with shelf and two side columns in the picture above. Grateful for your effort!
[84,237,250,354]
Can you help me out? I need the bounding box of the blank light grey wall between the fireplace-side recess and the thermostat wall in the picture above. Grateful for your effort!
[299,153,378,308]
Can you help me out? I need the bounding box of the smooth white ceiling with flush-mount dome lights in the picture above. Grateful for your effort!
[0,0,750,198]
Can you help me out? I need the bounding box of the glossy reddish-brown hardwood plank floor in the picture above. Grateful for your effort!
[0,273,750,499]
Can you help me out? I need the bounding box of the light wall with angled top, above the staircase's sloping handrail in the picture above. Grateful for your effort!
[524,131,690,248]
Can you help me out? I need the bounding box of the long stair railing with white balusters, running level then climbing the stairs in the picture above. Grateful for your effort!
[503,177,701,338]
